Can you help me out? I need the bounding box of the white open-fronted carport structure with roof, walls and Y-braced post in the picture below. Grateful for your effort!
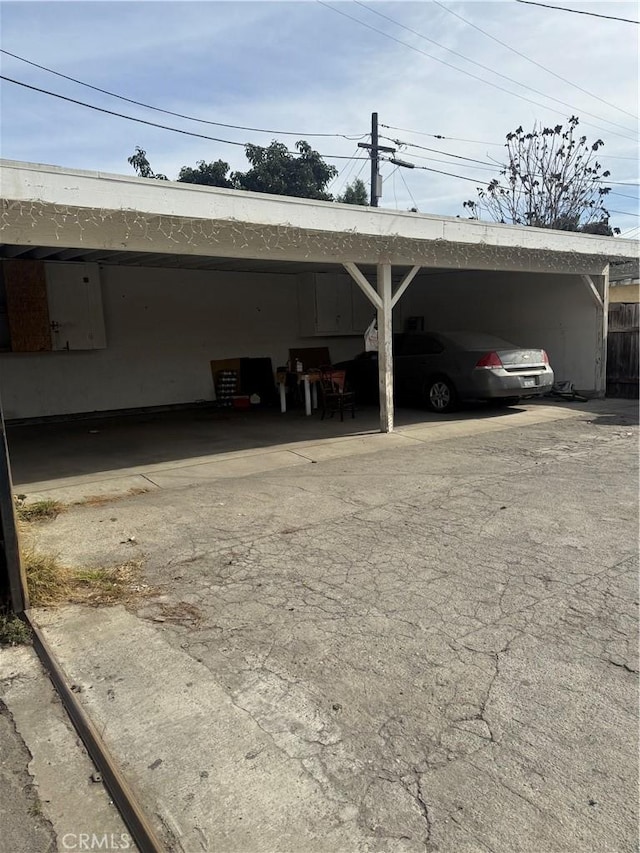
[0,161,637,432]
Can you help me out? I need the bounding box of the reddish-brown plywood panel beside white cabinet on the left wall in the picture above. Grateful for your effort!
[3,260,51,352]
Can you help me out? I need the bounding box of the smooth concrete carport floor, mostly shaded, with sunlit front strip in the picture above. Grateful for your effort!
[9,401,600,503]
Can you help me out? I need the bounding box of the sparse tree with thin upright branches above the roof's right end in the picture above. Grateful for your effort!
[463,116,620,235]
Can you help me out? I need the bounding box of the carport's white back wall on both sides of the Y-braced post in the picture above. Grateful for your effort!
[0,265,599,419]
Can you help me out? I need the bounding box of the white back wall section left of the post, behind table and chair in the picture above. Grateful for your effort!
[0,265,363,419]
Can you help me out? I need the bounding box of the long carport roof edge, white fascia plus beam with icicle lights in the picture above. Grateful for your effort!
[0,160,638,274]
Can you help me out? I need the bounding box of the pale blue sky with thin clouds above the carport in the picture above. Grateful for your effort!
[0,0,640,236]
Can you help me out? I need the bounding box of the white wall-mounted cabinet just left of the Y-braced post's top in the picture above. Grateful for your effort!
[298,273,375,337]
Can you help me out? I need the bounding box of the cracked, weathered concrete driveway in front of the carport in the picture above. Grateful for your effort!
[21,401,639,853]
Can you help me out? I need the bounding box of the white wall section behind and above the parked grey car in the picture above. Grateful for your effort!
[394,272,601,392]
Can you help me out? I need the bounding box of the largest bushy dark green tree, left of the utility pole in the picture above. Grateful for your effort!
[233,140,338,201]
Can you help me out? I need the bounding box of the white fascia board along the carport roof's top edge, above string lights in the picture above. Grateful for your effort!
[0,160,639,266]
